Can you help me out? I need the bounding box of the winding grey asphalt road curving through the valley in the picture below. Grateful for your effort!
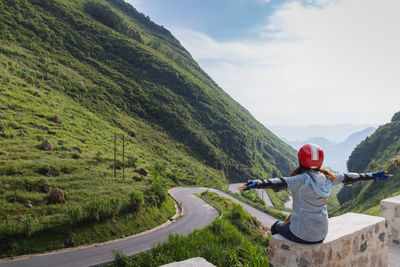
[0,187,276,267]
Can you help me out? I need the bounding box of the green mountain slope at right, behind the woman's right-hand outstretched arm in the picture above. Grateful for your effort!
[337,113,400,215]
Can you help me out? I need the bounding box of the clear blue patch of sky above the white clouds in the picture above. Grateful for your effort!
[128,0,285,41]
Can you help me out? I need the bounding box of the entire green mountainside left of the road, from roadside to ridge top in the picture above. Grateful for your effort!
[0,0,295,257]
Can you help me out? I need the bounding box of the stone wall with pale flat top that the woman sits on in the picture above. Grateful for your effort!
[268,213,388,267]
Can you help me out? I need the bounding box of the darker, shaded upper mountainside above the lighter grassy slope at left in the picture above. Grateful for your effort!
[0,0,295,180]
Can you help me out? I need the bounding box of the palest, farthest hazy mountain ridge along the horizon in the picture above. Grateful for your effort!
[267,124,378,143]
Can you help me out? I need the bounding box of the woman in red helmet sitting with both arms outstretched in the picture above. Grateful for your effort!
[238,144,392,244]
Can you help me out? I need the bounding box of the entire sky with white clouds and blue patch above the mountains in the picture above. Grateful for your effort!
[126,0,400,126]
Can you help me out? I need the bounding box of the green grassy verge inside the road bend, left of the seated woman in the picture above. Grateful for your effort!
[113,192,269,267]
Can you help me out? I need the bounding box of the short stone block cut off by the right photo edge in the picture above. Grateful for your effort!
[381,196,400,248]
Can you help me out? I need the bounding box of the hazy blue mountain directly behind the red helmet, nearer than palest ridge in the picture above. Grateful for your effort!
[287,127,375,171]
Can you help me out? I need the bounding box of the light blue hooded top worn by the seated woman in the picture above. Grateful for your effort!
[283,171,344,242]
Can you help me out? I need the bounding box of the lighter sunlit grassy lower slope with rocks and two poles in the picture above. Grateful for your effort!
[0,50,225,257]
